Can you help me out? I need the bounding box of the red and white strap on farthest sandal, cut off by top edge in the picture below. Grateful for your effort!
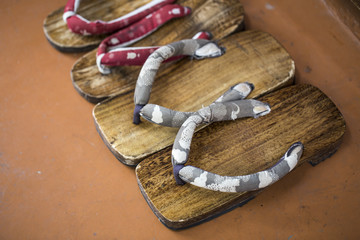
[63,0,175,35]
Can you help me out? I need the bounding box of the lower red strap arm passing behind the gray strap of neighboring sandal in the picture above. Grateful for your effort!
[96,32,212,74]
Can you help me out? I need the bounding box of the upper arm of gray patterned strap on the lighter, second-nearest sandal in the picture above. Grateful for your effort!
[133,39,225,124]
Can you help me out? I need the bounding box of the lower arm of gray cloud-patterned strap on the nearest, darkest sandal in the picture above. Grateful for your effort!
[174,142,304,192]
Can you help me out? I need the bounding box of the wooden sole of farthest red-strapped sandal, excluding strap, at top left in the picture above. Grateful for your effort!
[43,0,150,52]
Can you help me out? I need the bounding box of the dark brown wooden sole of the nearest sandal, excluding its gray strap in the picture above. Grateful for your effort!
[136,85,345,229]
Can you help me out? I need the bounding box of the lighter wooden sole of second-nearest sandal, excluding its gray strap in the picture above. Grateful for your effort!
[93,31,295,165]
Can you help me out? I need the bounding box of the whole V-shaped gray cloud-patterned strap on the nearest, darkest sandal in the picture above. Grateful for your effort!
[165,85,303,192]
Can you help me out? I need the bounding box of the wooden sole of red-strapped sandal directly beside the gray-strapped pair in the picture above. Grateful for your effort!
[71,0,244,103]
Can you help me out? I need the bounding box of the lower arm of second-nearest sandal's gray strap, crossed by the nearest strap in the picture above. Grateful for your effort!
[140,82,254,128]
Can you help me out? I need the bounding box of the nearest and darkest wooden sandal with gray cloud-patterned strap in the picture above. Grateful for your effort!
[136,85,345,229]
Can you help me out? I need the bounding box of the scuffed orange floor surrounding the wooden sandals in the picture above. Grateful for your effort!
[0,0,360,239]
